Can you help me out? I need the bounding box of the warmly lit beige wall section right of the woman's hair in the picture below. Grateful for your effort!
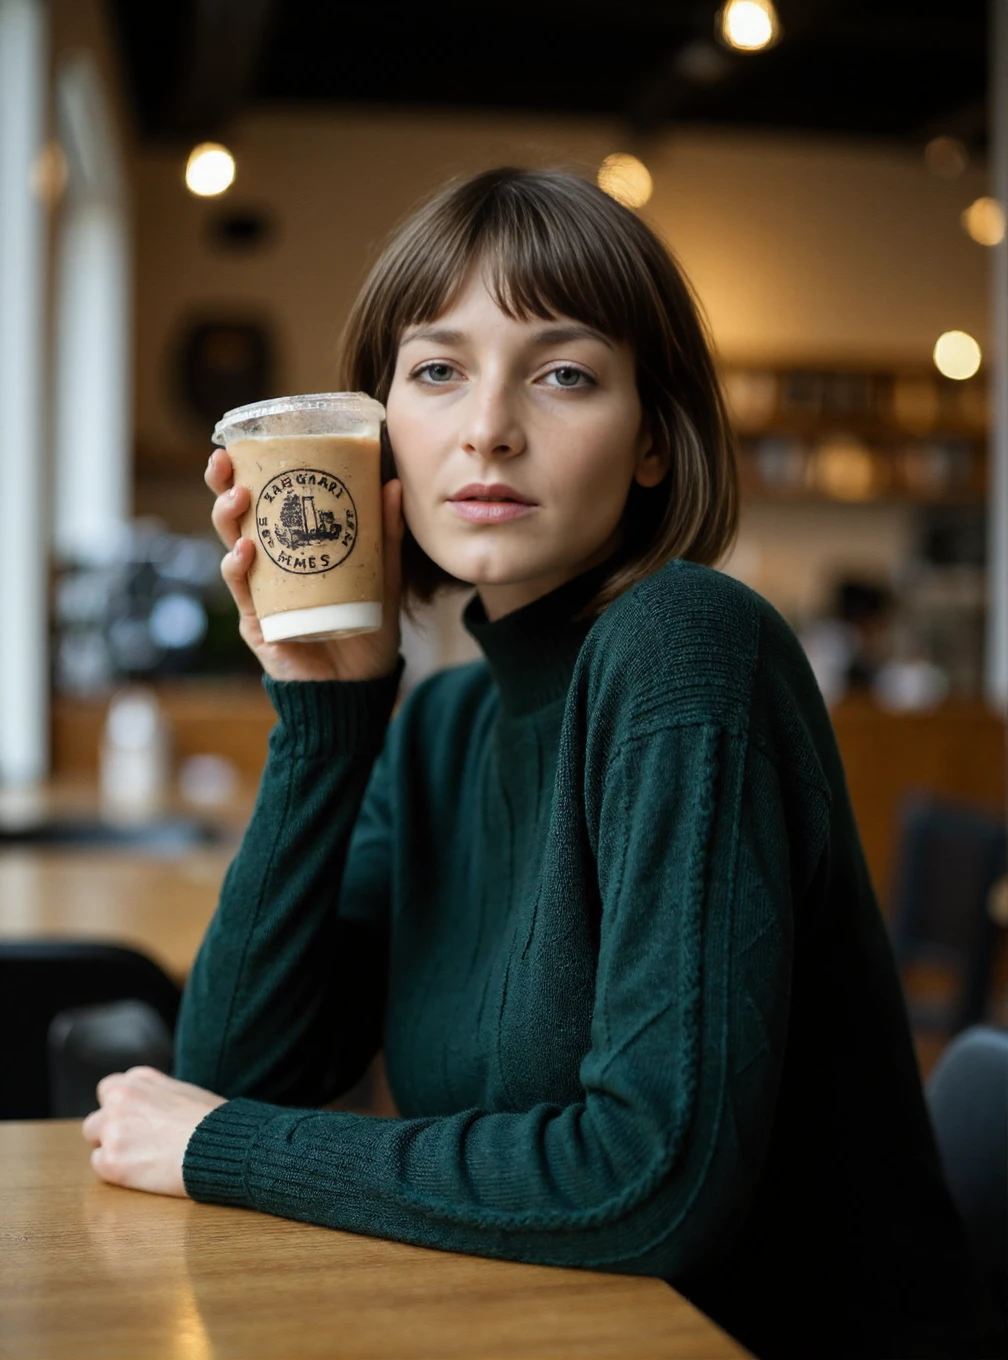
[649,135,989,364]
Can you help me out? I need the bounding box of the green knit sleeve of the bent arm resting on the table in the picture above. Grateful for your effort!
[184,725,810,1278]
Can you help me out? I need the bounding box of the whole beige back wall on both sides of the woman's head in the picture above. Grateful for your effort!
[135,112,988,469]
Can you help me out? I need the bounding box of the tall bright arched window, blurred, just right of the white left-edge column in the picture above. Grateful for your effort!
[53,53,132,562]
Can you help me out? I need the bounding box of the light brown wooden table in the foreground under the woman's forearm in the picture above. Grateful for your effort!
[0,1121,747,1360]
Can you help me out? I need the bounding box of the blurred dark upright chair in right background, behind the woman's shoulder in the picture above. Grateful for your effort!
[892,794,1005,1035]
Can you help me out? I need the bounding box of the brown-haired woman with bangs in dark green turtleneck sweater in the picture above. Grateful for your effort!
[84,170,970,1357]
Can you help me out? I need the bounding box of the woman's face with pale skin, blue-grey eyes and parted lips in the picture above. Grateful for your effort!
[386,273,665,619]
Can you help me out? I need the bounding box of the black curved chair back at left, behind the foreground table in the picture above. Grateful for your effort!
[0,940,181,1119]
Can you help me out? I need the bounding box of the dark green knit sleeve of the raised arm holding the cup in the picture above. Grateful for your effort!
[174,658,403,1104]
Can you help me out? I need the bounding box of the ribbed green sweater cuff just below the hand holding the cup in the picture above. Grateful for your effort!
[263,654,405,756]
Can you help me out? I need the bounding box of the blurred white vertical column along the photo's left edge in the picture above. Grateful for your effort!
[0,0,49,786]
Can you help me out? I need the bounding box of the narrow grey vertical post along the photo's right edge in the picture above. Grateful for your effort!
[985,0,1008,713]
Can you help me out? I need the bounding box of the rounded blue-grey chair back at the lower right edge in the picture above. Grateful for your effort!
[928,1025,1008,1322]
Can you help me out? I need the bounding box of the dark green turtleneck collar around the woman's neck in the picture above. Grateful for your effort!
[463,562,612,717]
